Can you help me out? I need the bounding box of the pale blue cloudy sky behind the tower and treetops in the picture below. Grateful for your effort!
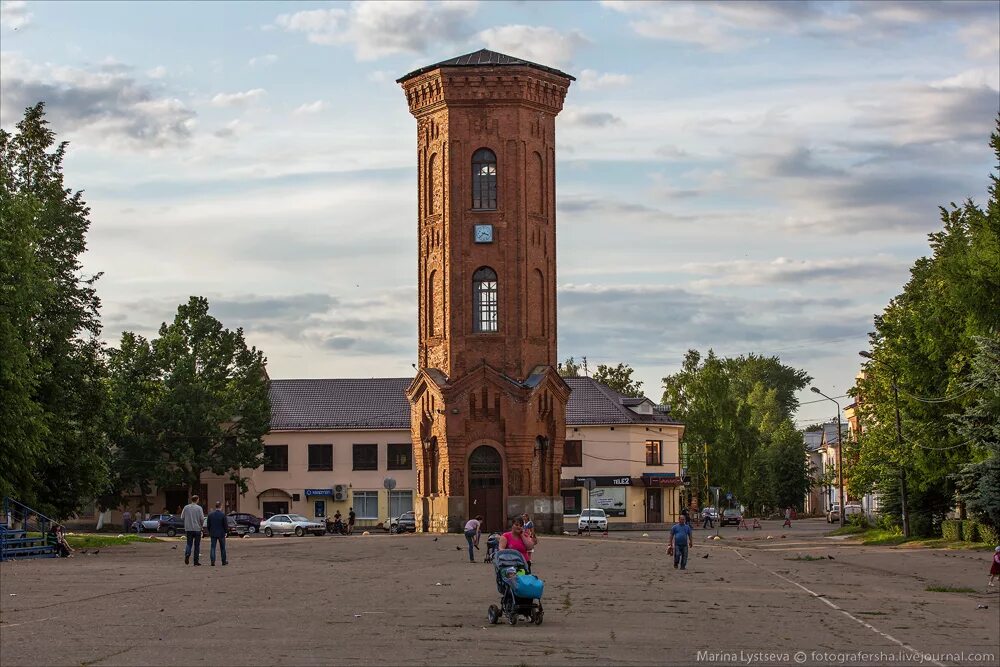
[0,0,1000,426]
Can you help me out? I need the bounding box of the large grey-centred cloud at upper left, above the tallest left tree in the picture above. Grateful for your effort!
[0,53,195,148]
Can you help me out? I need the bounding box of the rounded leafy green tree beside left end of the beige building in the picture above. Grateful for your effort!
[112,297,271,492]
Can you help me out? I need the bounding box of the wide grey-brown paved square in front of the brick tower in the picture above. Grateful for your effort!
[0,522,1000,667]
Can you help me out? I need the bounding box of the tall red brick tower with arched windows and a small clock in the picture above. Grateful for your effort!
[398,49,574,532]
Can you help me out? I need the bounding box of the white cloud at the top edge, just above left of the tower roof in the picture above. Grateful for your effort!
[275,0,476,60]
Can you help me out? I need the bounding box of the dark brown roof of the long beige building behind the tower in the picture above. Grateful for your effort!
[270,378,680,431]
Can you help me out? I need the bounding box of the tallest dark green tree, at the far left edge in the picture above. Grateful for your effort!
[0,103,107,517]
